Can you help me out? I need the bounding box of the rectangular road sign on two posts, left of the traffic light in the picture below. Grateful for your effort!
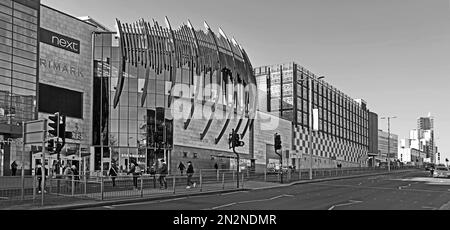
[22,120,47,206]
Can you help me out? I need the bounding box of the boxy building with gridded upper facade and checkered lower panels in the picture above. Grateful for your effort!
[255,63,378,168]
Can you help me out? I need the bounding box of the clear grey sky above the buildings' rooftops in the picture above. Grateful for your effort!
[41,0,450,162]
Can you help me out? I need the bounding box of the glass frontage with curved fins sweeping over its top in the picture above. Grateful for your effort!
[93,19,256,171]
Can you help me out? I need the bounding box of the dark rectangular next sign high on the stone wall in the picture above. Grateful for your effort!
[39,28,80,54]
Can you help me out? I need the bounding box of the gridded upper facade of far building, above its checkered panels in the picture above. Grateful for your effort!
[255,63,369,147]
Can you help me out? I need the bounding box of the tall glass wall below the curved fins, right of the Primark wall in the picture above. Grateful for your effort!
[93,33,174,170]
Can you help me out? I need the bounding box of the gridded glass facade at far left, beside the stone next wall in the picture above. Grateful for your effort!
[0,0,39,125]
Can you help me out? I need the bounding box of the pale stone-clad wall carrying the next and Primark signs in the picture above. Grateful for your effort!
[39,6,96,147]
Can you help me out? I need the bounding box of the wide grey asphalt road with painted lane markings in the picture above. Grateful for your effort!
[81,171,450,210]
